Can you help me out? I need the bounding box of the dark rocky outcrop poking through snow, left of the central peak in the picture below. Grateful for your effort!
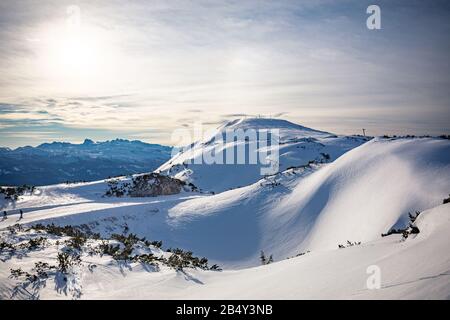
[128,173,184,197]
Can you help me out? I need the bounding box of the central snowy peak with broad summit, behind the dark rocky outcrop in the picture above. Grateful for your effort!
[156,118,369,193]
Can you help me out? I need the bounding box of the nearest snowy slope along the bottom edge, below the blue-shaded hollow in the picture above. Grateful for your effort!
[0,204,450,299]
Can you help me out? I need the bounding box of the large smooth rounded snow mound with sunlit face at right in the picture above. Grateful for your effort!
[272,139,450,255]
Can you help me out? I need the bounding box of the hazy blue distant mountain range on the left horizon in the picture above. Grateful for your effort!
[0,139,172,185]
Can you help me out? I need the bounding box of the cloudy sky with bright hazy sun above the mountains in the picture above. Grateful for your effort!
[0,0,450,148]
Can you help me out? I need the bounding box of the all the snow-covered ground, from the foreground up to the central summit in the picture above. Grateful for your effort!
[0,119,450,299]
